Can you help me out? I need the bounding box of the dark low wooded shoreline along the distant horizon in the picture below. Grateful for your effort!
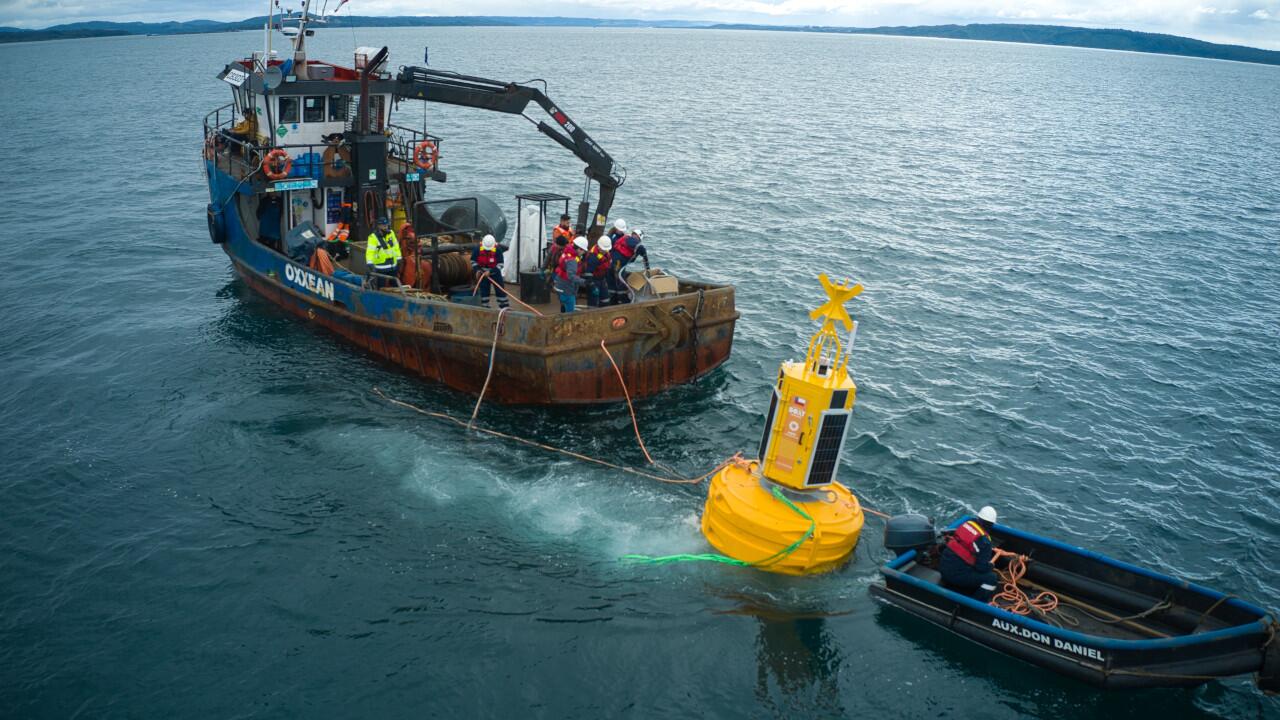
[0,15,1280,65]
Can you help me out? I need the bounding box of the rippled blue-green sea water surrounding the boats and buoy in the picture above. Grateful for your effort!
[0,28,1280,719]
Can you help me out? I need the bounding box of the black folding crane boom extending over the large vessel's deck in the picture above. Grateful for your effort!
[396,65,626,232]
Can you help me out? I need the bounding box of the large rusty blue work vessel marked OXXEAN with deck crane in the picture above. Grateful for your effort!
[204,3,739,405]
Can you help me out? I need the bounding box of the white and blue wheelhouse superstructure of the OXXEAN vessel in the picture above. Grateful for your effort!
[205,49,435,274]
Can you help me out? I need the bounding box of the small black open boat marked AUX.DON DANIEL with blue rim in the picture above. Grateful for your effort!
[870,515,1280,693]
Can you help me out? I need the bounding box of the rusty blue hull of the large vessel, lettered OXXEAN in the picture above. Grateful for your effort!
[206,161,739,405]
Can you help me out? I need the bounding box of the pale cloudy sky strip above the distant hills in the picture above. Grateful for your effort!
[0,0,1280,50]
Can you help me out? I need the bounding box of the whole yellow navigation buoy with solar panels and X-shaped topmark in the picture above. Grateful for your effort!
[703,275,864,575]
